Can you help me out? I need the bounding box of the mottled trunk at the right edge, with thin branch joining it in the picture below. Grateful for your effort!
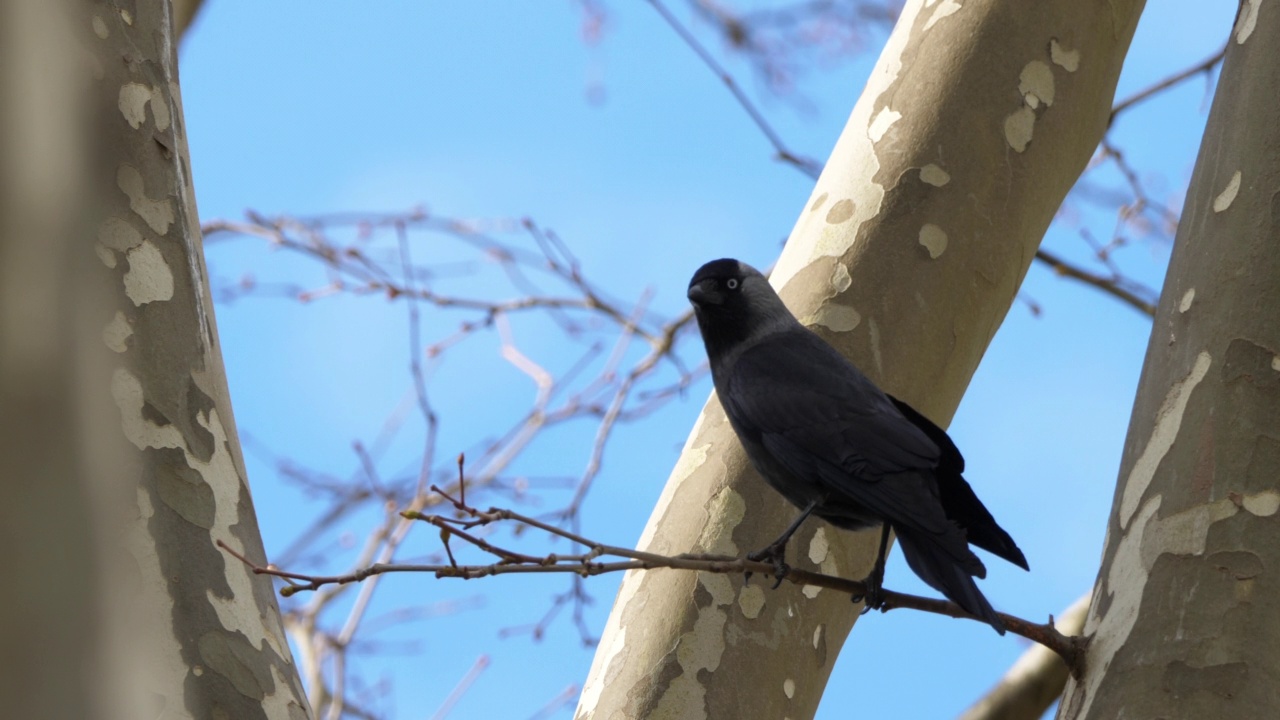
[1059,3,1280,719]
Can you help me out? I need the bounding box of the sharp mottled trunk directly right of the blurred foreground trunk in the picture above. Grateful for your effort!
[82,0,308,719]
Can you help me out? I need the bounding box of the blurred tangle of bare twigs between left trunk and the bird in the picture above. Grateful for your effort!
[205,210,705,720]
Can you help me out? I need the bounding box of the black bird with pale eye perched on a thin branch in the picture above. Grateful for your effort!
[689,259,1028,634]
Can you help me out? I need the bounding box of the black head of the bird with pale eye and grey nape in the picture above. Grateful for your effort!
[689,258,796,352]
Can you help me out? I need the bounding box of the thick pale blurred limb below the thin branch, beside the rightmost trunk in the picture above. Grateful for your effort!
[960,593,1092,720]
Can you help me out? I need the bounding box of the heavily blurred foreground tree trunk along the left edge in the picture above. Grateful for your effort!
[0,0,99,720]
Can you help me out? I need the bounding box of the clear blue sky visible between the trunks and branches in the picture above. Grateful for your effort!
[182,0,1233,717]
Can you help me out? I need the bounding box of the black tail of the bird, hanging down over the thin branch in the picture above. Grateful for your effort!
[893,527,1005,634]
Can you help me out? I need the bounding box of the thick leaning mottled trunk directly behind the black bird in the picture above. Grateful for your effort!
[576,0,1142,719]
